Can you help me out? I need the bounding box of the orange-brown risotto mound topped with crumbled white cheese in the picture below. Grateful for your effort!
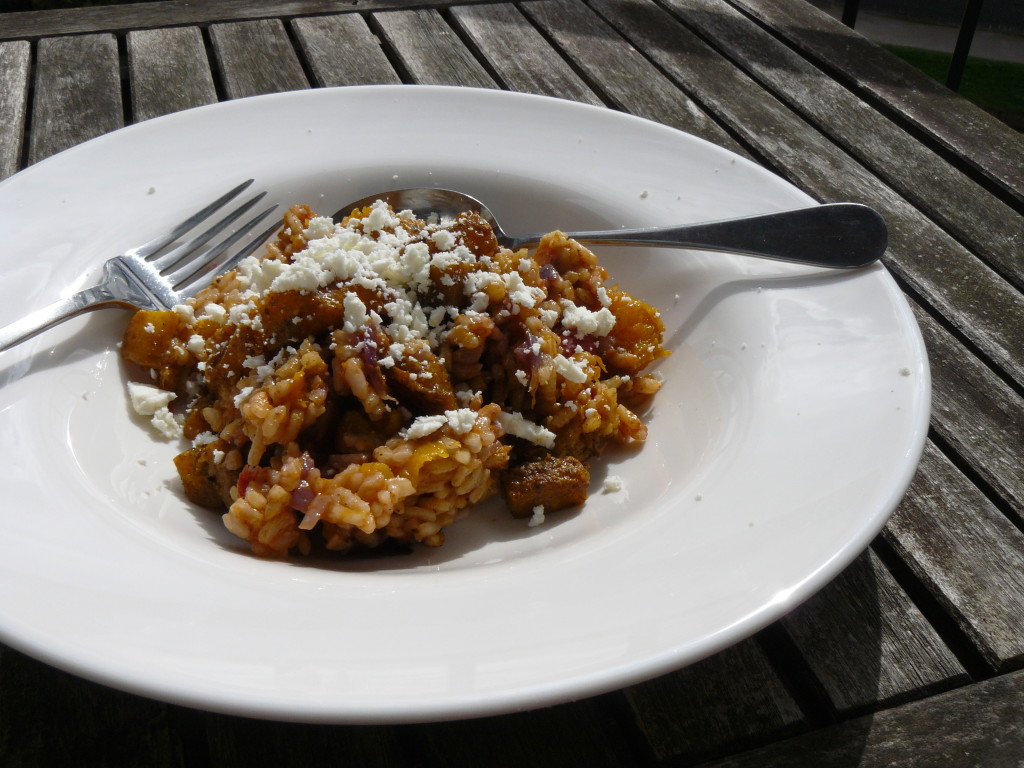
[122,202,667,557]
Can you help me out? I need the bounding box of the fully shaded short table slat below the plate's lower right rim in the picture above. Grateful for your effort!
[626,640,806,765]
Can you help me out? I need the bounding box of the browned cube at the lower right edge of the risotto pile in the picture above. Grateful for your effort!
[502,456,590,517]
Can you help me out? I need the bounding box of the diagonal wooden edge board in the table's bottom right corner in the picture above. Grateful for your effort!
[702,672,1024,768]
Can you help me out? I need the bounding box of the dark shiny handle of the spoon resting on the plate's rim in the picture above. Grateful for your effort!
[507,203,888,269]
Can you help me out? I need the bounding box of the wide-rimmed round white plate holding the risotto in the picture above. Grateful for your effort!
[0,86,929,723]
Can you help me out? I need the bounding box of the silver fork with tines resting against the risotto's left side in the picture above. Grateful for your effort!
[0,179,279,352]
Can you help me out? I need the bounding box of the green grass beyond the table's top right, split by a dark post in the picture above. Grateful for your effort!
[884,45,1024,131]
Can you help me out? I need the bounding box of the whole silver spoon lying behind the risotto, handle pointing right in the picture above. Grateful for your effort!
[334,187,888,269]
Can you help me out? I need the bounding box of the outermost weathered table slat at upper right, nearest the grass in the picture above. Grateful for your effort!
[729,0,1024,207]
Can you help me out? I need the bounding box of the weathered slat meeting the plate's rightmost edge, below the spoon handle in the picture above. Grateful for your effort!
[913,305,1024,528]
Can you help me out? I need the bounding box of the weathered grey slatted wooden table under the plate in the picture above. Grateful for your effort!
[0,0,1024,768]
